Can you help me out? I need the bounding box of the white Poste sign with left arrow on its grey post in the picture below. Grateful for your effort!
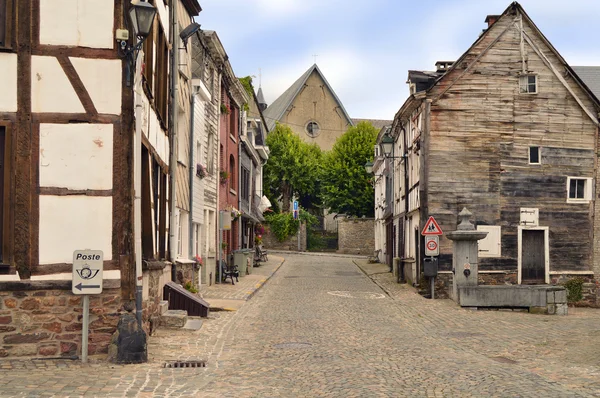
[71,250,104,363]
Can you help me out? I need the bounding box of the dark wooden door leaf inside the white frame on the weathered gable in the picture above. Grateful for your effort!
[521,230,546,284]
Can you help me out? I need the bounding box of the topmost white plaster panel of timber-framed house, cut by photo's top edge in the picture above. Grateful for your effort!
[40,0,115,48]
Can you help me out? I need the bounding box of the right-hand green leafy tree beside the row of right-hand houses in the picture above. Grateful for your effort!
[321,122,378,217]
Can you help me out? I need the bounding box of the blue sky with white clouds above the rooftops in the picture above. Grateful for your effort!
[196,0,600,120]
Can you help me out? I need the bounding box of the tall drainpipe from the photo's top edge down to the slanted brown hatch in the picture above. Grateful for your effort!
[169,0,181,282]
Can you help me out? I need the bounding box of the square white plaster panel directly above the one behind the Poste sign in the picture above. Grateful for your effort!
[40,123,113,189]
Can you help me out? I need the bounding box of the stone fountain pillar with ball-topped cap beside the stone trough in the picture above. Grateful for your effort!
[447,207,488,304]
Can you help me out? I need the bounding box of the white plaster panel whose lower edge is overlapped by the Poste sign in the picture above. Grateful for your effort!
[39,195,112,264]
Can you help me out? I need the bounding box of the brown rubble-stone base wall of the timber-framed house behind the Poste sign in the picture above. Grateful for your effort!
[0,280,121,357]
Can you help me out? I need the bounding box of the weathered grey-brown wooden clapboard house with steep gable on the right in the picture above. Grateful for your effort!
[385,2,600,296]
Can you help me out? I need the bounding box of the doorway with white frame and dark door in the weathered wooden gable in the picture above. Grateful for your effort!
[518,227,550,285]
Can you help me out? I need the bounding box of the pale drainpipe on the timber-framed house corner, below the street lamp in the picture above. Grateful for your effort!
[133,51,143,328]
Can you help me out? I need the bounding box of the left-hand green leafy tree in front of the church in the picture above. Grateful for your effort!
[263,123,322,212]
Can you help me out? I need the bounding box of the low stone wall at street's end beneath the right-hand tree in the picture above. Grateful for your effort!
[338,216,375,256]
